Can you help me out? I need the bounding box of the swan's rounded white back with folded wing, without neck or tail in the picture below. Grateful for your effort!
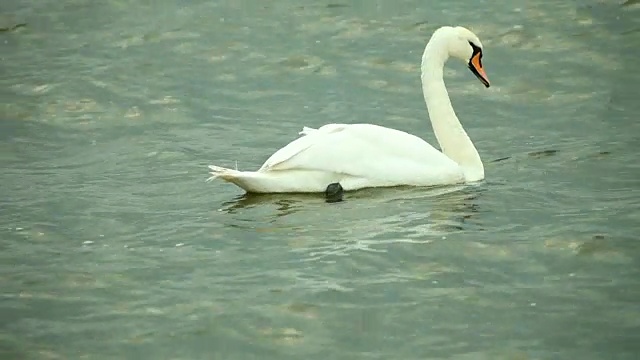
[259,124,462,185]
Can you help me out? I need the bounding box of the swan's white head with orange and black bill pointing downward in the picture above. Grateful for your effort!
[442,26,490,87]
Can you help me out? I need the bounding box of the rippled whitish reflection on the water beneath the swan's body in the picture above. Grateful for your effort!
[212,184,485,262]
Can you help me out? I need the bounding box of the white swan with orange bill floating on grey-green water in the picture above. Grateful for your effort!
[208,26,489,193]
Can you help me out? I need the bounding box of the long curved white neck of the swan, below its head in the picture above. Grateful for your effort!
[422,36,484,181]
